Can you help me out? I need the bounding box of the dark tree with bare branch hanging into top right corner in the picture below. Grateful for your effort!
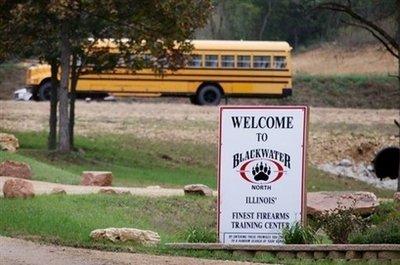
[317,0,400,191]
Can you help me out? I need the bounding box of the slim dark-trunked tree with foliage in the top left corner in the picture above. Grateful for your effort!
[0,0,59,150]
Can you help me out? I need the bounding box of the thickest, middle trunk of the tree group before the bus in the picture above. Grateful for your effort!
[58,24,71,153]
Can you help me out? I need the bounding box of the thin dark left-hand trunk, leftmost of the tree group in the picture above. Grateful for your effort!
[48,60,58,150]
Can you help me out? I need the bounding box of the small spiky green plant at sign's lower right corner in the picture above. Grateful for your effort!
[282,223,317,244]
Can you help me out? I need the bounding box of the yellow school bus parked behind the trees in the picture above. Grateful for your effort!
[26,40,292,105]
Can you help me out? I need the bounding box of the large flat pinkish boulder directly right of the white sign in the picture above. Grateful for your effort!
[307,191,379,215]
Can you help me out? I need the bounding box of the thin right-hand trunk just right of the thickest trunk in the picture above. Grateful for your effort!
[69,53,80,149]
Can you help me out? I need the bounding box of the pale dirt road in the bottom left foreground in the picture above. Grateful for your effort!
[0,237,268,265]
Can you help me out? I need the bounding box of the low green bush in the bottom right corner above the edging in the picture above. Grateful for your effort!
[349,216,400,244]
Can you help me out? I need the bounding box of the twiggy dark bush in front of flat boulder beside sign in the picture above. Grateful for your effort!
[316,202,367,244]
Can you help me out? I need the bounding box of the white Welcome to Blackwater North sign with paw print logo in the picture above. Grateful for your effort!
[218,106,308,244]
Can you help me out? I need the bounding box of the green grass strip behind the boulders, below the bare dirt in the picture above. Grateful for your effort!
[0,129,393,197]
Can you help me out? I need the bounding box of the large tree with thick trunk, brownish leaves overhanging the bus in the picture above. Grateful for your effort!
[0,0,211,152]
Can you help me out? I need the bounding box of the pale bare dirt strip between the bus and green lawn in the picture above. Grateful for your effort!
[0,101,398,164]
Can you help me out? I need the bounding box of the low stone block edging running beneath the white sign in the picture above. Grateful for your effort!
[166,243,400,262]
